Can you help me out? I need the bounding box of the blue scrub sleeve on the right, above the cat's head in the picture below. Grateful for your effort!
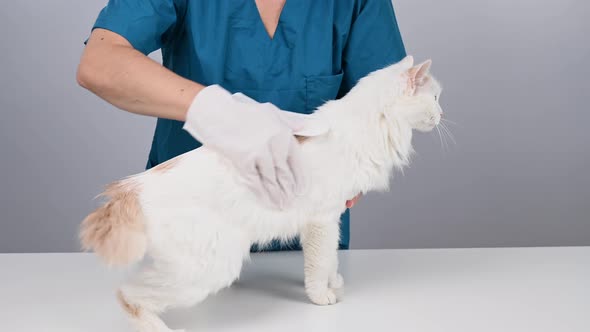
[339,0,406,95]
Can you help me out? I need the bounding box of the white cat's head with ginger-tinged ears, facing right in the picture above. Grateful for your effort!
[376,56,442,132]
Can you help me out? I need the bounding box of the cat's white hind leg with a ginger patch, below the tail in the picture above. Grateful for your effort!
[119,219,250,332]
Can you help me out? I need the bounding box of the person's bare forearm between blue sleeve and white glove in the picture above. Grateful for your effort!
[77,29,204,121]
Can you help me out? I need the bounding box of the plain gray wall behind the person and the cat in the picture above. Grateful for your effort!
[0,0,590,252]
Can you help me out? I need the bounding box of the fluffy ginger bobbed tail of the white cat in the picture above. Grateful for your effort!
[79,179,148,266]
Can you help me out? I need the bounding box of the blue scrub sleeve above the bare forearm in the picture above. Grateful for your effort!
[92,0,186,55]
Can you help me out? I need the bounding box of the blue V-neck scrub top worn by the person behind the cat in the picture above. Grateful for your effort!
[94,0,406,250]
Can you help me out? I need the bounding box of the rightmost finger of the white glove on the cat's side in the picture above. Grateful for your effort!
[269,133,295,204]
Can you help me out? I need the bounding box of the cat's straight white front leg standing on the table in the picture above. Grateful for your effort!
[301,219,343,305]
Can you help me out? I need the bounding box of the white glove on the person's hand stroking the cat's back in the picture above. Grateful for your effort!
[183,85,328,208]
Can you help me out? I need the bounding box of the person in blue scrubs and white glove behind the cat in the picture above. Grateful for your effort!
[77,0,406,250]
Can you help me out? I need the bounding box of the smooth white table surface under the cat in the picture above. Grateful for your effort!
[0,247,590,332]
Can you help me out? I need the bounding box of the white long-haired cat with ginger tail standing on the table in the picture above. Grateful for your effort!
[80,57,441,332]
